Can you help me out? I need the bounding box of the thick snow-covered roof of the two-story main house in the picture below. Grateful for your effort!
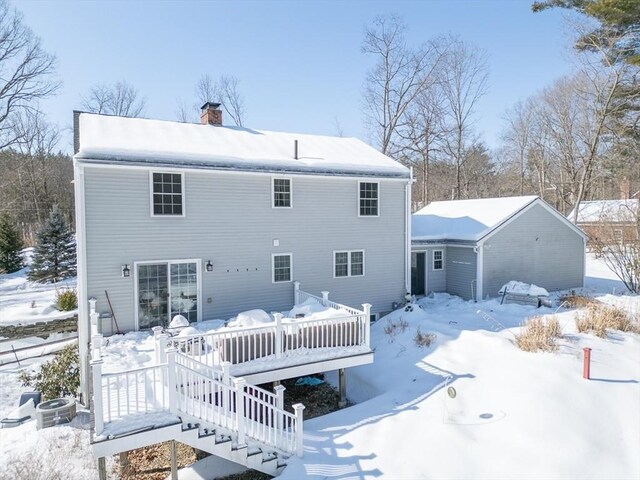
[76,113,410,178]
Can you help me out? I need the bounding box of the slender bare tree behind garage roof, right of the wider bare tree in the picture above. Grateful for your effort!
[440,35,489,198]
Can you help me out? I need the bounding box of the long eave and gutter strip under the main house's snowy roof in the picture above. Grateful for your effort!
[73,155,411,181]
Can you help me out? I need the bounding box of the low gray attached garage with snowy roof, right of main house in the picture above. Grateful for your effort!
[411,196,586,300]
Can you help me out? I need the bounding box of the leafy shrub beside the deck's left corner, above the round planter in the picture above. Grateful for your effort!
[18,345,80,400]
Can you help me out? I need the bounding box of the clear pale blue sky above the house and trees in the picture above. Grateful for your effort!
[14,0,571,150]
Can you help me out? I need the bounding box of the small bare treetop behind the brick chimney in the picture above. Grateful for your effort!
[196,75,246,127]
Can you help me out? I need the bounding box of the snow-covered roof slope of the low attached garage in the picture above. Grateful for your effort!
[411,196,538,241]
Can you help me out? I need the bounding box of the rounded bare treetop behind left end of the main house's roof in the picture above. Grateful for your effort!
[82,81,147,117]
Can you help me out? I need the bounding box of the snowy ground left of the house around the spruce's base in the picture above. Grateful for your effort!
[0,248,77,326]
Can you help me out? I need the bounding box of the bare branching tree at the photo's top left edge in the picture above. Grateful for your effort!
[0,0,60,149]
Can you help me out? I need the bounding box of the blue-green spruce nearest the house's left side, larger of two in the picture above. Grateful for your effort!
[28,207,76,283]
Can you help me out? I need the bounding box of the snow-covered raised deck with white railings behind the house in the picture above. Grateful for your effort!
[91,288,373,453]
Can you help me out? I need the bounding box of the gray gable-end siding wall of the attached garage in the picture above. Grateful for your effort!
[483,205,584,297]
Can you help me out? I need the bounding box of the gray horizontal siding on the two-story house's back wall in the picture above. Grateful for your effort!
[85,166,405,330]
